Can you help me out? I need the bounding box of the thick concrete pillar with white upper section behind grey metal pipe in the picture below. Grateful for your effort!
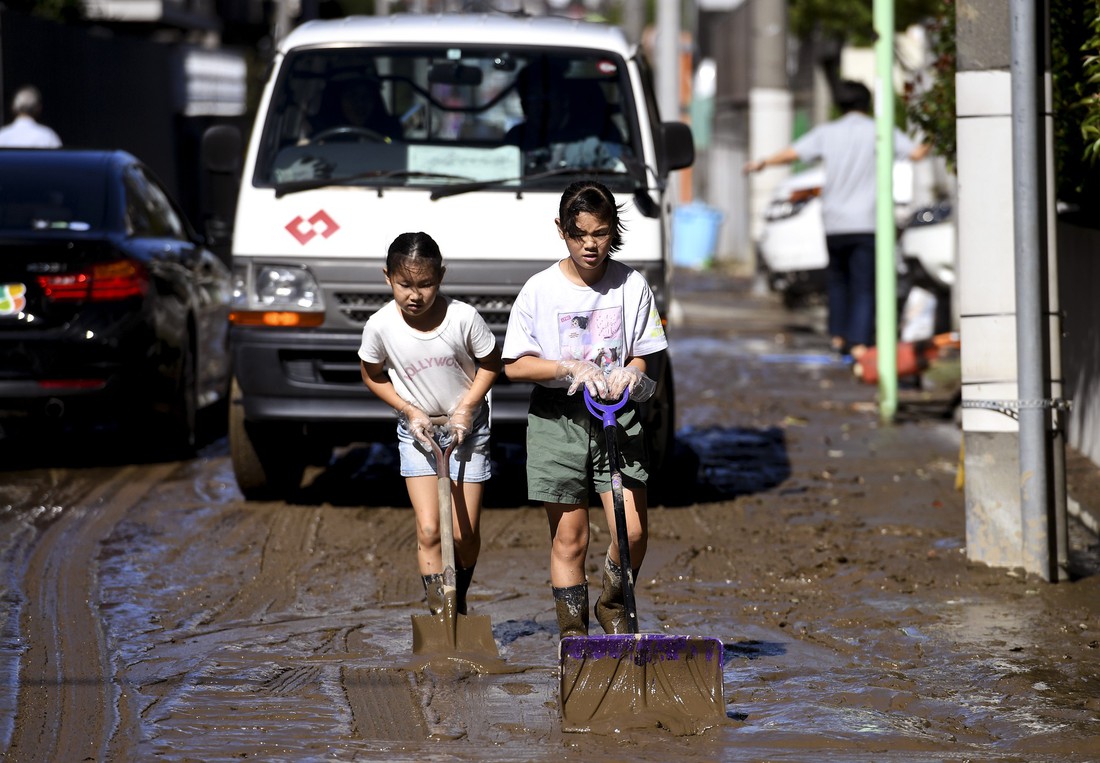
[956,0,1062,576]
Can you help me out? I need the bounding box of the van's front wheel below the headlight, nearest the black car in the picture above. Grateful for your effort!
[229,377,306,500]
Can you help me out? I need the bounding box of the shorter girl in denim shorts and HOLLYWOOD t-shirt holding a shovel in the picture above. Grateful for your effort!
[359,233,501,615]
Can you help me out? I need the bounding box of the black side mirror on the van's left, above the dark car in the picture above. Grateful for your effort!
[199,124,243,264]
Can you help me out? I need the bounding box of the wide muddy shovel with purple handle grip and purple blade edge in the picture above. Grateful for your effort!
[559,388,726,734]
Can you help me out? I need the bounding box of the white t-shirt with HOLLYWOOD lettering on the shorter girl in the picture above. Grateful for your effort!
[359,296,496,416]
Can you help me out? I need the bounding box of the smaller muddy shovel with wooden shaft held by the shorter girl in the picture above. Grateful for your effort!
[413,422,498,657]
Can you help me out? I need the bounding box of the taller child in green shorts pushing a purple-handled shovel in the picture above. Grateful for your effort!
[503,180,668,638]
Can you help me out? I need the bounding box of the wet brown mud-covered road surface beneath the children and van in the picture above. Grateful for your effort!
[0,274,1100,762]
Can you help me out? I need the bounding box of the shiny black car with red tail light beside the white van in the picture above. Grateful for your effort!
[0,150,232,452]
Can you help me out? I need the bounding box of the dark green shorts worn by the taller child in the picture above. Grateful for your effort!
[527,385,649,505]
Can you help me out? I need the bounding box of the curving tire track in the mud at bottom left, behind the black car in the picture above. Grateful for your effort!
[6,463,178,762]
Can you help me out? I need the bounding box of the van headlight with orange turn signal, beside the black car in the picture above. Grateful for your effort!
[230,263,325,325]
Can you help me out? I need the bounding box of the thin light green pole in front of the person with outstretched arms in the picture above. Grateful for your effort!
[872,0,898,423]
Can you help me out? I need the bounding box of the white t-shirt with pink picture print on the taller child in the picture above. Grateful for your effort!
[503,259,669,387]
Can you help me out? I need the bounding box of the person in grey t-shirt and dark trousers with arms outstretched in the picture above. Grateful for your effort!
[744,80,930,360]
